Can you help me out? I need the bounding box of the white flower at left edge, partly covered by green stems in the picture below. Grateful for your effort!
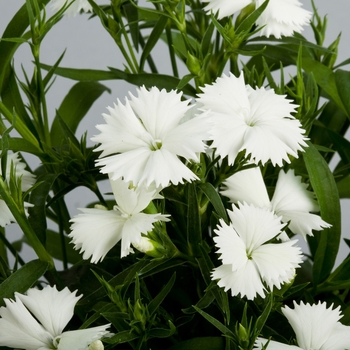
[0,152,35,227]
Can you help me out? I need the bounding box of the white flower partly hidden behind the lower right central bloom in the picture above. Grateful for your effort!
[221,168,331,240]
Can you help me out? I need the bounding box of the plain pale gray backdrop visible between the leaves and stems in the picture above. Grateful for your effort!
[0,0,350,264]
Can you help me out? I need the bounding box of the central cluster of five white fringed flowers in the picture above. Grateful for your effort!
[70,74,329,299]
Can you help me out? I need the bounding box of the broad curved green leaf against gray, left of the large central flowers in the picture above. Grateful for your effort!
[51,81,110,146]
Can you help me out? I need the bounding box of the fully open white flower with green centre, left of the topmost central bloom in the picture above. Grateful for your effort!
[92,87,208,188]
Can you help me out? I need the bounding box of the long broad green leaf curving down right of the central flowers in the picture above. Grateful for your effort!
[304,143,341,286]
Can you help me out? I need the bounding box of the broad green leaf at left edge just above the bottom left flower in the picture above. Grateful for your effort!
[0,260,49,306]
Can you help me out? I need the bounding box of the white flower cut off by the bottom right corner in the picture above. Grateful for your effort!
[255,301,350,350]
